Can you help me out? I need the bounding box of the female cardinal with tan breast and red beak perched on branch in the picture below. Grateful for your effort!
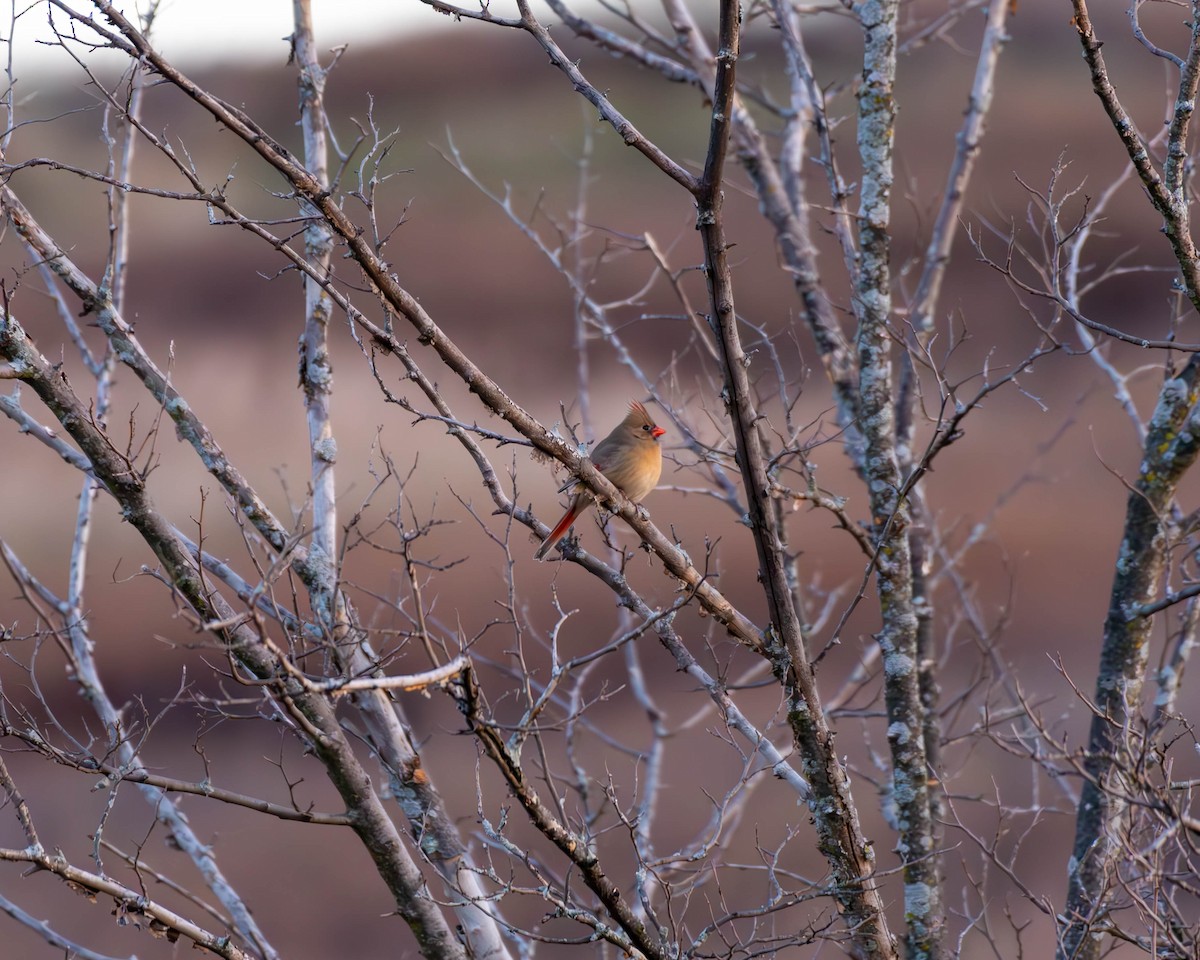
[533,400,666,560]
